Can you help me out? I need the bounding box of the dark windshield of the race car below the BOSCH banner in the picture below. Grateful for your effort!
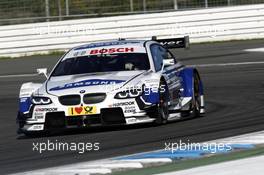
[51,53,150,76]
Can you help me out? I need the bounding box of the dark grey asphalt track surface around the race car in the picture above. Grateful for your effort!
[0,40,264,174]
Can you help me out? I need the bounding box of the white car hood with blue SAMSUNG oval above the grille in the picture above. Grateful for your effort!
[46,71,146,96]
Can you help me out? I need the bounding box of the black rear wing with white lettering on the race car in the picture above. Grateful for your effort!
[152,36,190,49]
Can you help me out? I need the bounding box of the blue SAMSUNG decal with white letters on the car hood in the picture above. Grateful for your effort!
[50,79,125,91]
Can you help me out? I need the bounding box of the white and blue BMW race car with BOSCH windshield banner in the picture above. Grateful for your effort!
[17,37,205,134]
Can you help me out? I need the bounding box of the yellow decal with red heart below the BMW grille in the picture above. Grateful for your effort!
[68,106,97,116]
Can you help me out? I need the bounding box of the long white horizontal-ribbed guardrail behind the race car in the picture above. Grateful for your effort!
[0,4,264,56]
